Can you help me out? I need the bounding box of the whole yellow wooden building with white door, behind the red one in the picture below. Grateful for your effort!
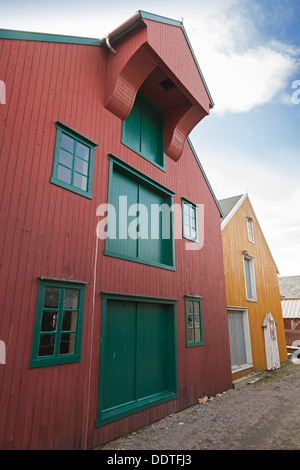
[219,194,288,380]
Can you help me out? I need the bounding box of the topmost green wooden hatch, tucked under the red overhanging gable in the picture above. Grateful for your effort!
[122,93,165,169]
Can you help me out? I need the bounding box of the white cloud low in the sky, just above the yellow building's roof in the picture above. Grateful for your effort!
[193,146,300,276]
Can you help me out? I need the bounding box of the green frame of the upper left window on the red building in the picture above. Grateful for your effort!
[50,121,98,199]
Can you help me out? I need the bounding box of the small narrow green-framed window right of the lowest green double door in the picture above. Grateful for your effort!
[185,297,204,347]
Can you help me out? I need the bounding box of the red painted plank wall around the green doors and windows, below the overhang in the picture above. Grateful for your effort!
[0,35,231,449]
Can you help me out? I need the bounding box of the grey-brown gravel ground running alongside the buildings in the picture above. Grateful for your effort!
[98,361,300,450]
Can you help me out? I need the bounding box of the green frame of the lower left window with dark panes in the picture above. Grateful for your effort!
[30,277,87,368]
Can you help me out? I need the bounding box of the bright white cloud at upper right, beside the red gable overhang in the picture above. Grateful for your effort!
[207,46,295,113]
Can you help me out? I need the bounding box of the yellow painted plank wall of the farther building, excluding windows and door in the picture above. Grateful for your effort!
[222,198,288,370]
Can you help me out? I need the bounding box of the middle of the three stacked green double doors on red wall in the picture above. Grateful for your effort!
[105,156,175,270]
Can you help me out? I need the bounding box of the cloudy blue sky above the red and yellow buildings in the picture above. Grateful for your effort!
[0,0,300,276]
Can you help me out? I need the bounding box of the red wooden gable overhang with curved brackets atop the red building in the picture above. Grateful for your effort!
[100,11,214,161]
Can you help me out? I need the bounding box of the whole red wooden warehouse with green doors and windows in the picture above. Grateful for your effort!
[0,11,232,449]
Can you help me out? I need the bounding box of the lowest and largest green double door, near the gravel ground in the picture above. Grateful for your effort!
[97,299,177,425]
